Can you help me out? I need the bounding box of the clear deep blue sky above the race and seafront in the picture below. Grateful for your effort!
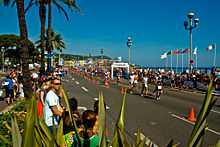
[0,0,220,66]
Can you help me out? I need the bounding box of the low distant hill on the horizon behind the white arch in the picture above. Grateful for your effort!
[57,54,112,60]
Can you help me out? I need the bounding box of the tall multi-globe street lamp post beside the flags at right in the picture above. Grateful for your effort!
[184,12,199,73]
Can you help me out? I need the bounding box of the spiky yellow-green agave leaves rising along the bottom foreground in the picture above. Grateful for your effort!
[0,77,220,147]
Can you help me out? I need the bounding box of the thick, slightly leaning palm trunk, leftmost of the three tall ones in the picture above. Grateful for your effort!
[16,0,32,98]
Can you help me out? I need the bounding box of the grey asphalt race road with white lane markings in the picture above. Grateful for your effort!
[63,74,220,147]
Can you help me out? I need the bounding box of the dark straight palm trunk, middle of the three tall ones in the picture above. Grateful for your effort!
[39,0,46,73]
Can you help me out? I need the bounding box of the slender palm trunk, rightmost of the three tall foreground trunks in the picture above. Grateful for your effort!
[47,0,52,72]
